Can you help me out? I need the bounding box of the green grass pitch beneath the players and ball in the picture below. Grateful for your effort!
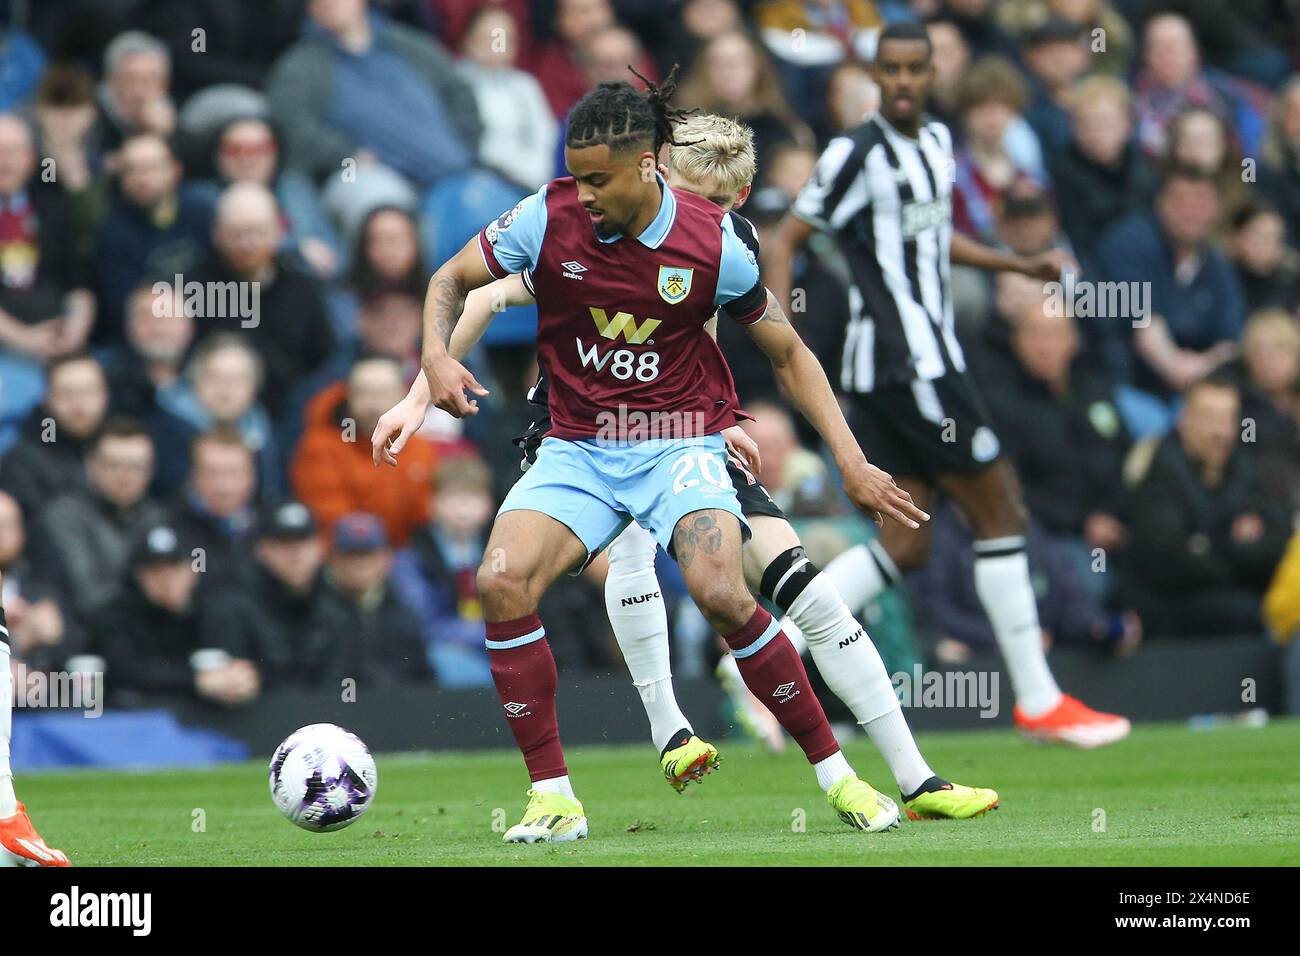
[18,721,1300,866]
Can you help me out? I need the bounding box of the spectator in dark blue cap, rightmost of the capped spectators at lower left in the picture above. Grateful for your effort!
[319,511,433,692]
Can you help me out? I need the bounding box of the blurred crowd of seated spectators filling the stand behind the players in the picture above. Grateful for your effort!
[0,0,1300,709]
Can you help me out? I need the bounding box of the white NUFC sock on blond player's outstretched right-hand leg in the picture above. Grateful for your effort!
[781,571,935,793]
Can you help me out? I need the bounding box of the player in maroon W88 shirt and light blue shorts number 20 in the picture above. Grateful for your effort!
[373,76,928,843]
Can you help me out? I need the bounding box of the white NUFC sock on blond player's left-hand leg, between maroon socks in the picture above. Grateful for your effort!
[605,523,690,753]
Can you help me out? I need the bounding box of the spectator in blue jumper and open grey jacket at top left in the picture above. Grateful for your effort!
[267,0,482,186]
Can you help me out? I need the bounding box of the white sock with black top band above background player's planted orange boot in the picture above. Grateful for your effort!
[975,536,1061,717]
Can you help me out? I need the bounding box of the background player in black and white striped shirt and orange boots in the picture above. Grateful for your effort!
[763,22,1128,747]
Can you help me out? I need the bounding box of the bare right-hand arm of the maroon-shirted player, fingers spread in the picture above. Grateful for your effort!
[745,291,930,528]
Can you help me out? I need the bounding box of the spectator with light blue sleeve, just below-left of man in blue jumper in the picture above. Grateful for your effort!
[199,117,343,278]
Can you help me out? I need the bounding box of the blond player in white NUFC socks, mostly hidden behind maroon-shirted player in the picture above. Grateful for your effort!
[380,114,998,819]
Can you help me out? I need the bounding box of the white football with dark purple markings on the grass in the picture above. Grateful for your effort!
[269,723,380,832]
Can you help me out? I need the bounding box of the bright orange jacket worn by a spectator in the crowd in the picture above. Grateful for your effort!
[289,382,438,548]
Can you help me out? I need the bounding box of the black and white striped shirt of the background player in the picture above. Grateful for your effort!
[793,113,966,392]
